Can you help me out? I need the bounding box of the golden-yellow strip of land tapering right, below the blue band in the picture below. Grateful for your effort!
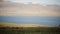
[0,22,58,27]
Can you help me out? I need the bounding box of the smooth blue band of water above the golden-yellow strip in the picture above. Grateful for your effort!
[0,16,60,26]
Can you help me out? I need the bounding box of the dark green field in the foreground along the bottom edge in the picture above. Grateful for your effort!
[0,27,60,34]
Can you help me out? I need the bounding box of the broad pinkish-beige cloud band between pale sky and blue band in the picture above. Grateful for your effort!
[0,2,60,16]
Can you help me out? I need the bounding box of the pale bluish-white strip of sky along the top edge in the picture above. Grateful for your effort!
[6,0,60,5]
